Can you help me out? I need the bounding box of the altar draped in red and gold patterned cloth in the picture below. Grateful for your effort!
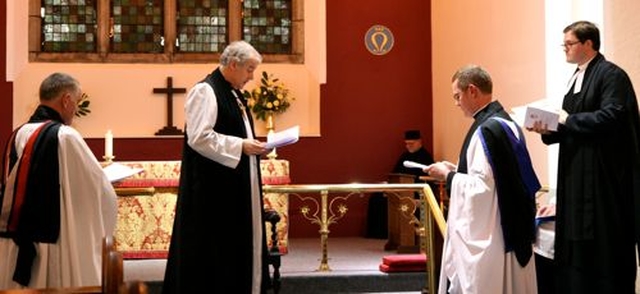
[114,159,291,259]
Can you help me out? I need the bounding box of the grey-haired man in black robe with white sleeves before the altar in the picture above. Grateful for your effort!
[162,41,270,294]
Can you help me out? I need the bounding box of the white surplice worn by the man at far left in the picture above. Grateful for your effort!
[0,123,117,289]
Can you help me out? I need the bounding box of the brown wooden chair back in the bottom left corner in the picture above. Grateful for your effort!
[0,236,149,294]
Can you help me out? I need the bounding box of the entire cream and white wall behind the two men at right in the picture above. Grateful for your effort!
[431,0,640,187]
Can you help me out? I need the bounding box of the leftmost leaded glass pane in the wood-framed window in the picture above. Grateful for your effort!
[41,0,97,53]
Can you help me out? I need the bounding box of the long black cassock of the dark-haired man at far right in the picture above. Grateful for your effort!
[542,54,640,293]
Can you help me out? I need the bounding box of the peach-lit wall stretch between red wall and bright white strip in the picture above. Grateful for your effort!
[431,0,547,179]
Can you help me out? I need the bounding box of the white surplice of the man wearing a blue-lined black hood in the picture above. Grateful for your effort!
[438,124,538,294]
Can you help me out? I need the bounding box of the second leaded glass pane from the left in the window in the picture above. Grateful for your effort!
[111,0,164,53]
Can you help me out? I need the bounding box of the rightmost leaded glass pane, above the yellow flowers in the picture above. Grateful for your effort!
[242,0,292,54]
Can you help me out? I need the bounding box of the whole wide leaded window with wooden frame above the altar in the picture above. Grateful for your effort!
[33,0,305,63]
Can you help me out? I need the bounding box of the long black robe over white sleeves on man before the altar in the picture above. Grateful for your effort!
[162,69,269,294]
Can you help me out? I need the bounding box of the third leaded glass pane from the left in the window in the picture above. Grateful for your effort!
[177,0,229,53]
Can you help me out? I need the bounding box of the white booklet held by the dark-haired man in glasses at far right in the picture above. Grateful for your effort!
[512,99,560,131]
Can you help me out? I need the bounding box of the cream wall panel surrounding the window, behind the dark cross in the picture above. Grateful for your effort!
[7,0,326,138]
